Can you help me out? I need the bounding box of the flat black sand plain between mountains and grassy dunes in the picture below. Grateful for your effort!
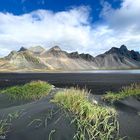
[0,73,140,94]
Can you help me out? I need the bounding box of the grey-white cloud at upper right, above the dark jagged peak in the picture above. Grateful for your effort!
[101,0,140,51]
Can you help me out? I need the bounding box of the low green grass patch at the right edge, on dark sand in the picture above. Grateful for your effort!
[103,84,140,103]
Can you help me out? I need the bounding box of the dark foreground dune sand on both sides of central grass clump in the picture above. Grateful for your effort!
[0,88,140,140]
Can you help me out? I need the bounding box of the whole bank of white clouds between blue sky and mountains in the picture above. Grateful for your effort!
[0,0,140,56]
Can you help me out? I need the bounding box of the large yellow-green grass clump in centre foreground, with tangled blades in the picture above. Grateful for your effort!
[53,88,119,140]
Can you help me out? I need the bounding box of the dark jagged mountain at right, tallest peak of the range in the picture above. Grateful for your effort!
[95,45,140,69]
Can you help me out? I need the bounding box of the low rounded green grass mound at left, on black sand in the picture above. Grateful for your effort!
[0,81,53,100]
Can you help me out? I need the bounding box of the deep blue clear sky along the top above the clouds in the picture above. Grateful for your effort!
[0,0,121,20]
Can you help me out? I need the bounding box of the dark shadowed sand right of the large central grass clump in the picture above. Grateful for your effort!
[91,95,140,140]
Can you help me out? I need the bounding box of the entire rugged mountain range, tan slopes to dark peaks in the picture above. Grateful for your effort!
[0,45,140,71]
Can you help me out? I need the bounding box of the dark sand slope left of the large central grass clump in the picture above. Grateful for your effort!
[0,89,76,140]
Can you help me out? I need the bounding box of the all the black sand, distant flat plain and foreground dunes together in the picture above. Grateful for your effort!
[0,73,140,140]
